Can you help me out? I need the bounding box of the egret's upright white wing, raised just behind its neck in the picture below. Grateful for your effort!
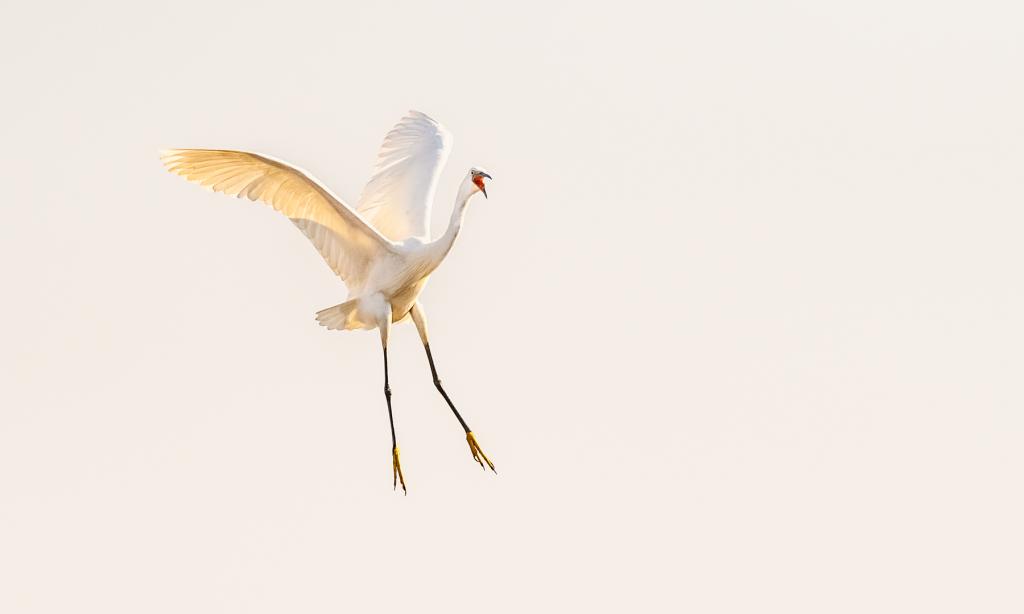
[355,111,452,242]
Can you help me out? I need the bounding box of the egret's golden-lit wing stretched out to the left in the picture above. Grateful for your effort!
[160,149,395,290]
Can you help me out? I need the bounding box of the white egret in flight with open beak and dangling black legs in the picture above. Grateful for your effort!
[161,111,497,493]
